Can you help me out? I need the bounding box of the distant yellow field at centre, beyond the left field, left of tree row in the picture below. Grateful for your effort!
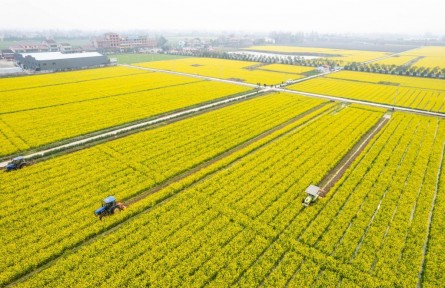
[136,58,306,85]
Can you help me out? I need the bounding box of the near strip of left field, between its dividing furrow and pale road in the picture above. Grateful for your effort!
[0,79,248,156]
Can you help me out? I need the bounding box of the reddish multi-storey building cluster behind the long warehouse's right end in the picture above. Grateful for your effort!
[92,33,157,52]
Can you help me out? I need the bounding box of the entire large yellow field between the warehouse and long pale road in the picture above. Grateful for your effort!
[0,68,253,156]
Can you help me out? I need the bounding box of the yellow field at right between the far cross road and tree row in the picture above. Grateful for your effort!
[288,72,445,112]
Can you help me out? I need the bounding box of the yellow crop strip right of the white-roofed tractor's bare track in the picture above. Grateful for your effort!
[280,114,445,287]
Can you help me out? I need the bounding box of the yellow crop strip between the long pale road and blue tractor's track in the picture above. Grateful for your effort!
[0,93,331,283]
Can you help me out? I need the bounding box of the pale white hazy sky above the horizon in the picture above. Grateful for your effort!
[0,0,445,34]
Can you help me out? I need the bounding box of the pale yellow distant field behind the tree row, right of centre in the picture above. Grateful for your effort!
[246,46,388,64]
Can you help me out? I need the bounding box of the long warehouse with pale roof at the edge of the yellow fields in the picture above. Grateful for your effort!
[15,52,110,71]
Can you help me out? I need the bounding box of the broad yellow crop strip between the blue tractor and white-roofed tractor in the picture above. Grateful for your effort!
[12,108,382,287]
